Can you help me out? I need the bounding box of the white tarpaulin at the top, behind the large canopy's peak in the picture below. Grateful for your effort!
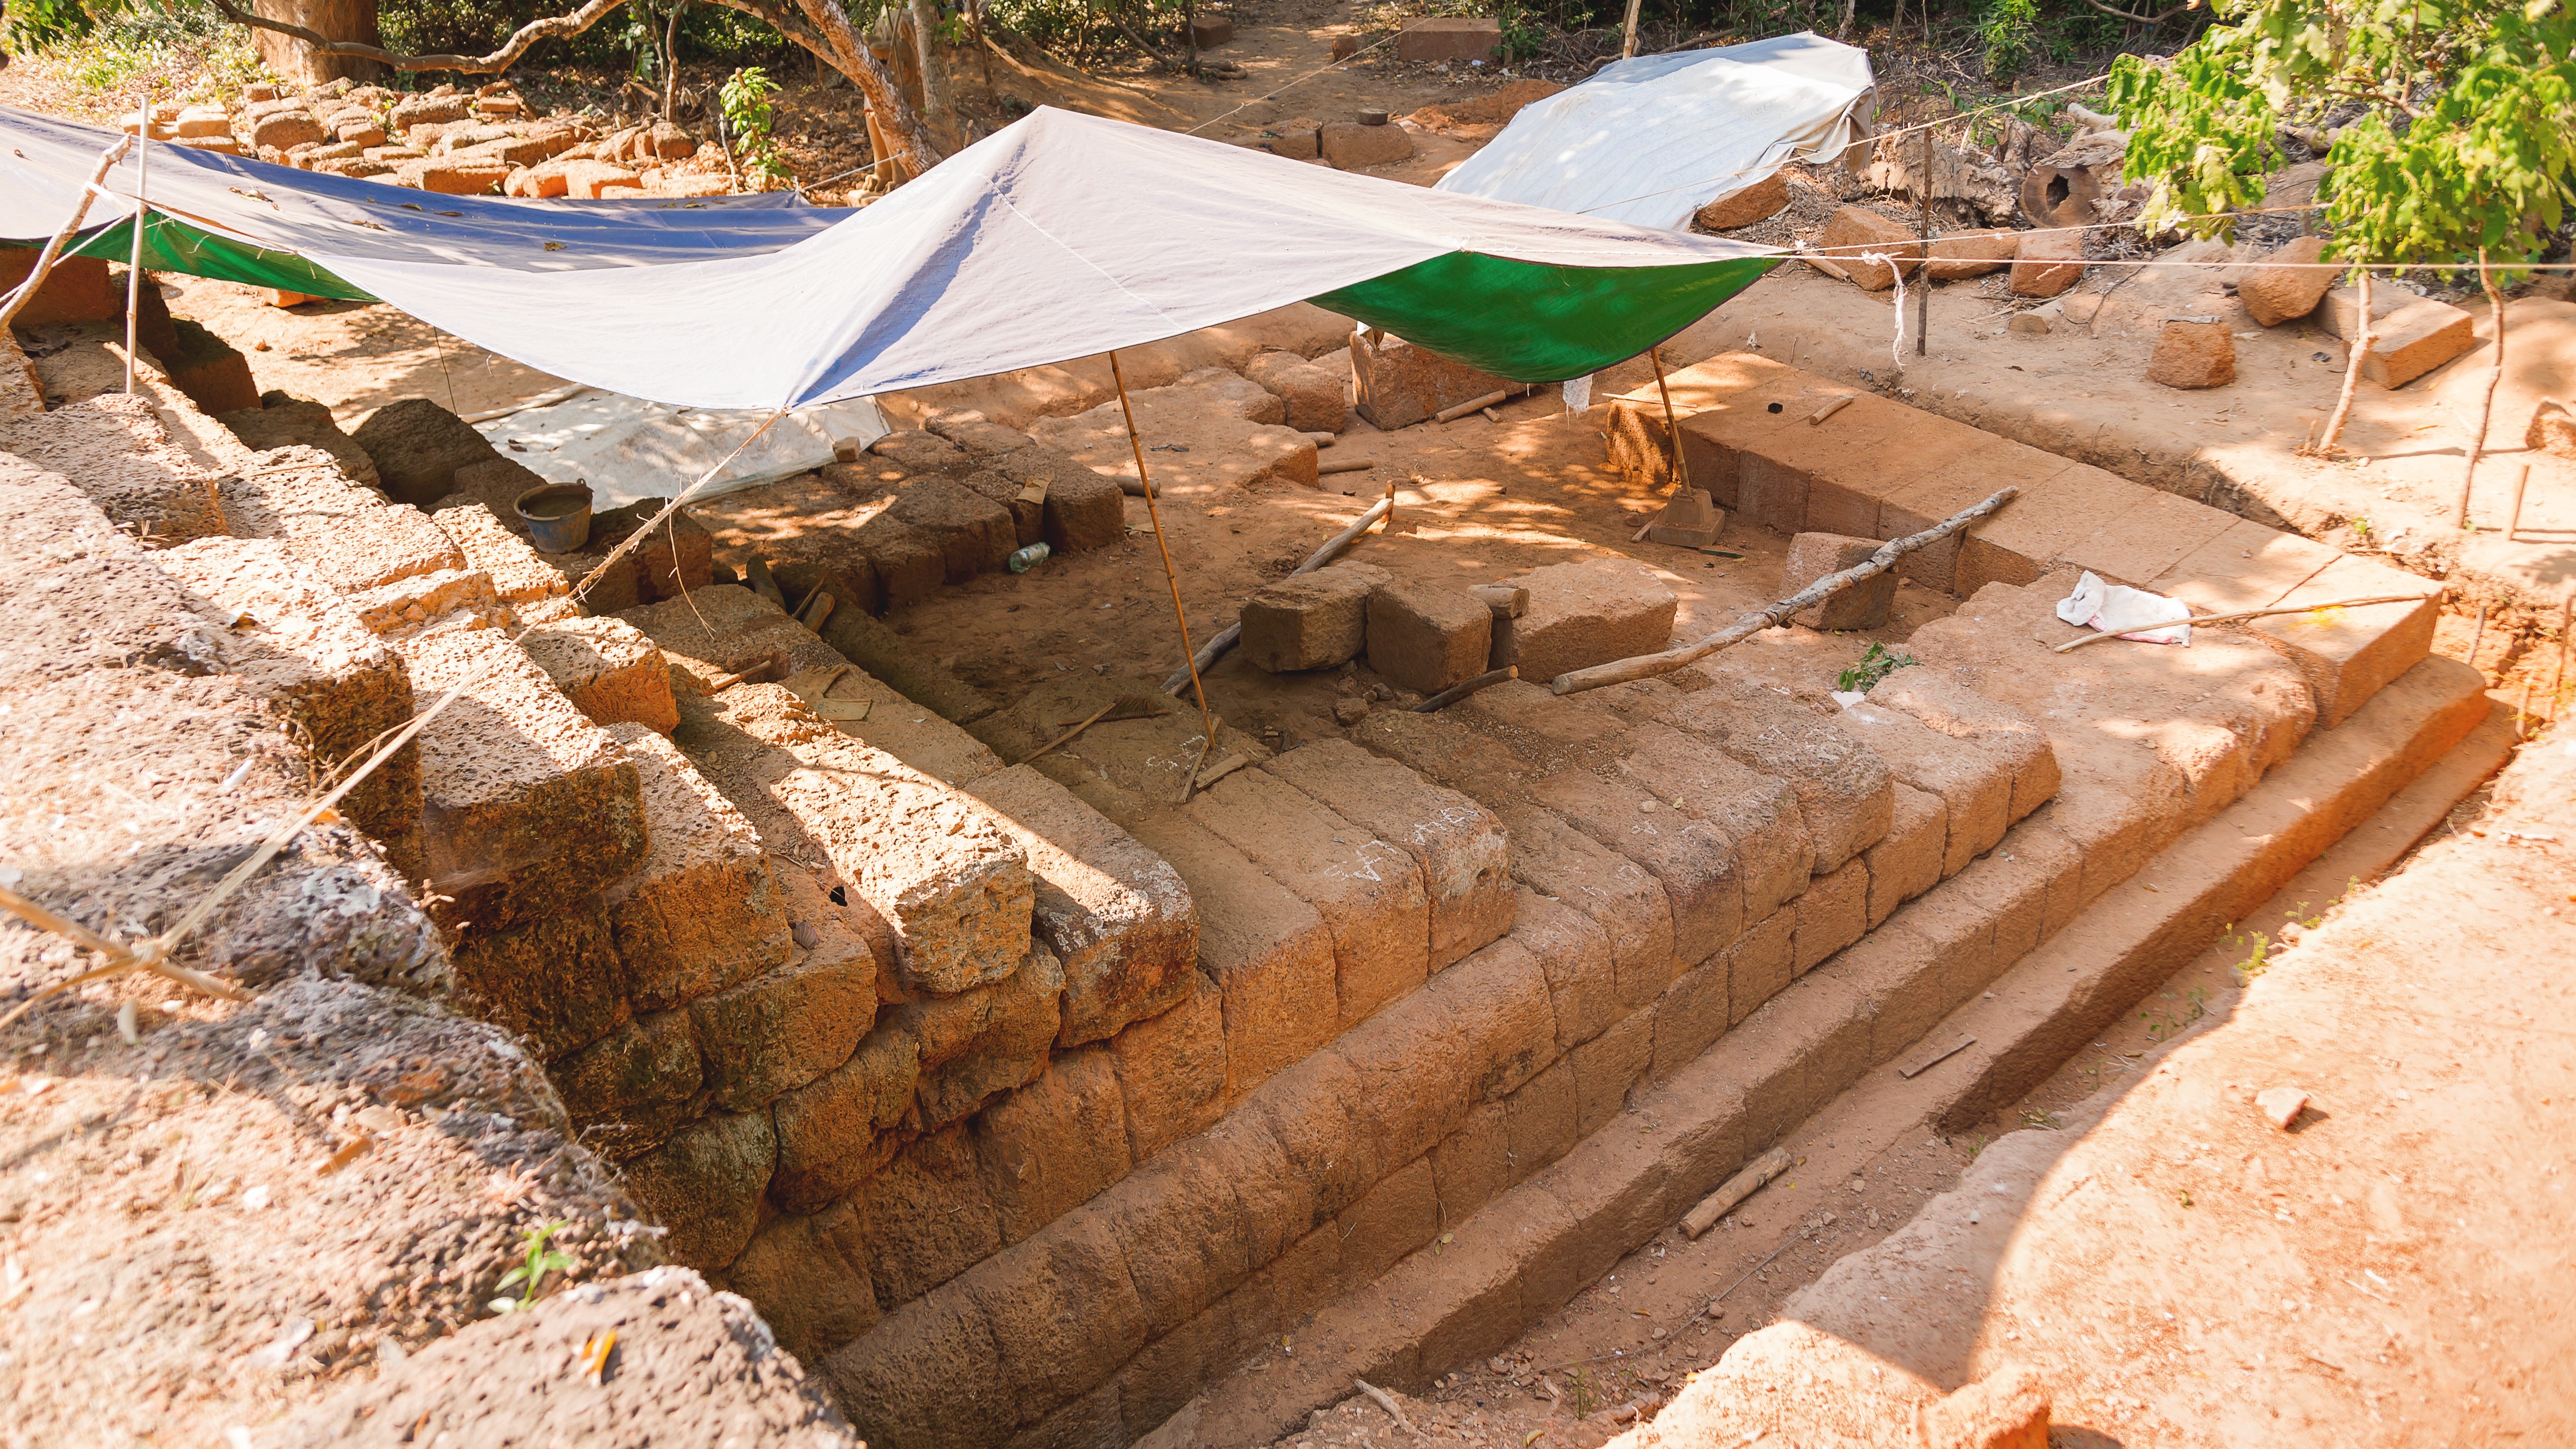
[1440,31,1878,229]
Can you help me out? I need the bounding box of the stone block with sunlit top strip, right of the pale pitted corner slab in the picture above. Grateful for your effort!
[971,765,1198,1047]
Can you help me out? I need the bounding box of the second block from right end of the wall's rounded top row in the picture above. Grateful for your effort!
[1602,663,1896,874]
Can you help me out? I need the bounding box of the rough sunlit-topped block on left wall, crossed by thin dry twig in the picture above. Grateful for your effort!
[155,539,420,838]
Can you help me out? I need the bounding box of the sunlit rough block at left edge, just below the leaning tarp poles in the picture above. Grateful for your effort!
[8,394,229,547]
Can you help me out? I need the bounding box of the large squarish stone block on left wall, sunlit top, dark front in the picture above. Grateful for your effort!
[397,629,649,931]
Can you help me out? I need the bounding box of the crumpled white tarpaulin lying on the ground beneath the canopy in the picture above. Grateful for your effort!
[474,389,886,511]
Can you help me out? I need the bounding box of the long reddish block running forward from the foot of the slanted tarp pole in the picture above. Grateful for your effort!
[1182,768,1432,1029]
